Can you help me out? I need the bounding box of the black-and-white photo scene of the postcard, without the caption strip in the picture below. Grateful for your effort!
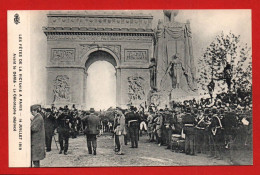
[8,10,253,167]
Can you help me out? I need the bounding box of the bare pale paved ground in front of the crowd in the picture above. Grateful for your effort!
[41,135,250,167]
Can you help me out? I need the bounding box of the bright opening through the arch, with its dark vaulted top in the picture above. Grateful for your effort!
[85,51,117,110]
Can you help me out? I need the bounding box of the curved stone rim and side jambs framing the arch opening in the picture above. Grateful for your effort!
[82,48,121,108]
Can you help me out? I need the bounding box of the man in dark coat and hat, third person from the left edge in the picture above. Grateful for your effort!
[57,108,71,155]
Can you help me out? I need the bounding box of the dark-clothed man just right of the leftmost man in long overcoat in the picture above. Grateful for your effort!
[44,108,56,152]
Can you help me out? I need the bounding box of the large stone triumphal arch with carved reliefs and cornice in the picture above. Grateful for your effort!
[43,13,154,107]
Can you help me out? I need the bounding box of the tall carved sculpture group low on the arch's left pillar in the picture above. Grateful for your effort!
[53,75,70,102]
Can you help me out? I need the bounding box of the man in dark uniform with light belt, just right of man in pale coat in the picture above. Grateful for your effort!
[126,106,140,148]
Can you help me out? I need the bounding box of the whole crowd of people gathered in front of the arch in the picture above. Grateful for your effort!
[31,93,252,167]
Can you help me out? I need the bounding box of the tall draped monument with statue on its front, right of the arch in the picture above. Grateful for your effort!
[155,10,197,93]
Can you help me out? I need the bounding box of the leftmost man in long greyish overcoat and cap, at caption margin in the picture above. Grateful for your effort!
[31,105,45,167]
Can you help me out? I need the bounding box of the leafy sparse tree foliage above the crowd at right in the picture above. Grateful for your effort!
[198,32,252,95]
